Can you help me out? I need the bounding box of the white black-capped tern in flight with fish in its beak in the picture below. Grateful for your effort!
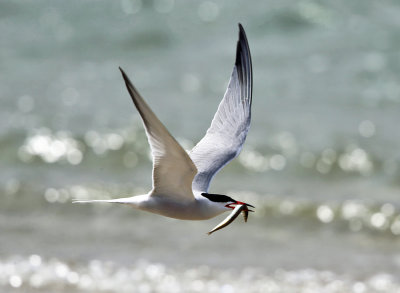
[75,23,253,234]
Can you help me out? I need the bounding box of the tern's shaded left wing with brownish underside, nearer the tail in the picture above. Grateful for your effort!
[120,68,197,200]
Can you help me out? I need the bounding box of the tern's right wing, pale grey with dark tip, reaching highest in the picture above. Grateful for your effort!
[189,24,253,192]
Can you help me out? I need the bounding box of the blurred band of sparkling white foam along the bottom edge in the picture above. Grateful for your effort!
[0,254,400,293]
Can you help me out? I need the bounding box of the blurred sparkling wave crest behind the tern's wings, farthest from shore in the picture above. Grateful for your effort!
[0,128,400,184]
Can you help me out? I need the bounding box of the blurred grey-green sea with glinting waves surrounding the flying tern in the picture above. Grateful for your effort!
[0,0,400,293]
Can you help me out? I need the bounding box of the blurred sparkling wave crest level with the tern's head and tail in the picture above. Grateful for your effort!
[0,180,400,237]
